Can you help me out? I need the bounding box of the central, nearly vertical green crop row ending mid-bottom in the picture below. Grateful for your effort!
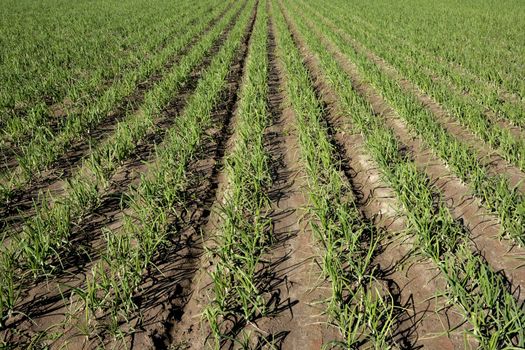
[203,1,272,349]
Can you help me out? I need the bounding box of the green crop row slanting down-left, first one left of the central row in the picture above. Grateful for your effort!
[70,3,253,335]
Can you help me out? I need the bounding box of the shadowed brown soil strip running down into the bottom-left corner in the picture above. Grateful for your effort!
[0,3,251,345]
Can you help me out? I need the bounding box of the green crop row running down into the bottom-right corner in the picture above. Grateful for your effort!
[280,0,525,348]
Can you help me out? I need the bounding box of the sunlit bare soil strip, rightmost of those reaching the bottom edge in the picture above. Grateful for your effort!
[283,4,476,349]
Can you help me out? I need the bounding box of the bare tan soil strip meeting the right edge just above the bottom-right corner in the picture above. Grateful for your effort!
[290,5,525,300]
